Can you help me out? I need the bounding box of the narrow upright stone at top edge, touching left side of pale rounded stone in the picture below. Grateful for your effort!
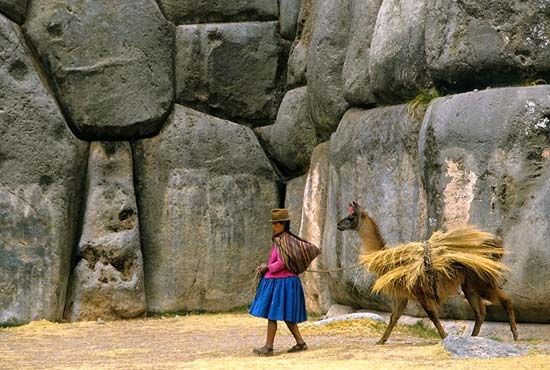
[342,0,382,105]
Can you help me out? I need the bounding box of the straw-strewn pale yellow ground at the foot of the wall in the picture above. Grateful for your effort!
[0,313,550,370]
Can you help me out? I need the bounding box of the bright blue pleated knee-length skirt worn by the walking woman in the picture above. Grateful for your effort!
[249,276,307,323]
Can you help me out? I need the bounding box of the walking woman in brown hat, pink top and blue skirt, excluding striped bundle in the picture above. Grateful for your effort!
[250,209,314,356]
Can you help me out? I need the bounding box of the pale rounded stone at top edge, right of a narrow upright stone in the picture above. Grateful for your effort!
[369,0,432,104]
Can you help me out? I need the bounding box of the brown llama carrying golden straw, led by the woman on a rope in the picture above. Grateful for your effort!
[337,202,518,344]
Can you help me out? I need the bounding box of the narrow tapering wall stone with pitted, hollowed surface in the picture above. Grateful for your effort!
[65,142,147,321]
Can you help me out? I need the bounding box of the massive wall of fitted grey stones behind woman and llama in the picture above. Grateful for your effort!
[0,0,550,324]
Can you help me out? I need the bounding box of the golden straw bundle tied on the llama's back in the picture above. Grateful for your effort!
[360,226,506,296]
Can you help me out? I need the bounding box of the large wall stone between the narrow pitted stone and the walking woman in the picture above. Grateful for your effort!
[134,105,279,312]
